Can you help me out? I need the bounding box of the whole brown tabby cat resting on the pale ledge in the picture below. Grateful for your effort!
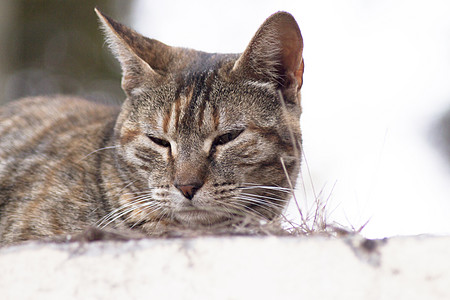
[0,9,304,245]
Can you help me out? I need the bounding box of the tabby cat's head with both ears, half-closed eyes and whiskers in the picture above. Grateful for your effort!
[97,11,303,224]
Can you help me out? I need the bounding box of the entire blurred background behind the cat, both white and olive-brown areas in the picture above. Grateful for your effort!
[0,0,450,237]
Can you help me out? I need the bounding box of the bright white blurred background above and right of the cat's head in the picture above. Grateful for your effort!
[130,0,450,237]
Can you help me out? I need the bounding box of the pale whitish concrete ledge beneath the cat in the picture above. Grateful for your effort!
[0,237,450,300]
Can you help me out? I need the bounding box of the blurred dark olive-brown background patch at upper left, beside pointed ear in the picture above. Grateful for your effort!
[0,0,132,103]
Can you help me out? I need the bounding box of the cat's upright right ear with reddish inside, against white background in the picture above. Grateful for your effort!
[233,12,304,98]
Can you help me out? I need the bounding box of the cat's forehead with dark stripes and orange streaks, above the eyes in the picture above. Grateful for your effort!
[144,69,275,137]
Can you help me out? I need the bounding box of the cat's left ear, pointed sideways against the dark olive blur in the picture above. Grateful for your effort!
[95,8,173,95]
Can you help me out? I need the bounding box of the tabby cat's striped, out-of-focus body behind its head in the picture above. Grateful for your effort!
[0,96,119,244]
